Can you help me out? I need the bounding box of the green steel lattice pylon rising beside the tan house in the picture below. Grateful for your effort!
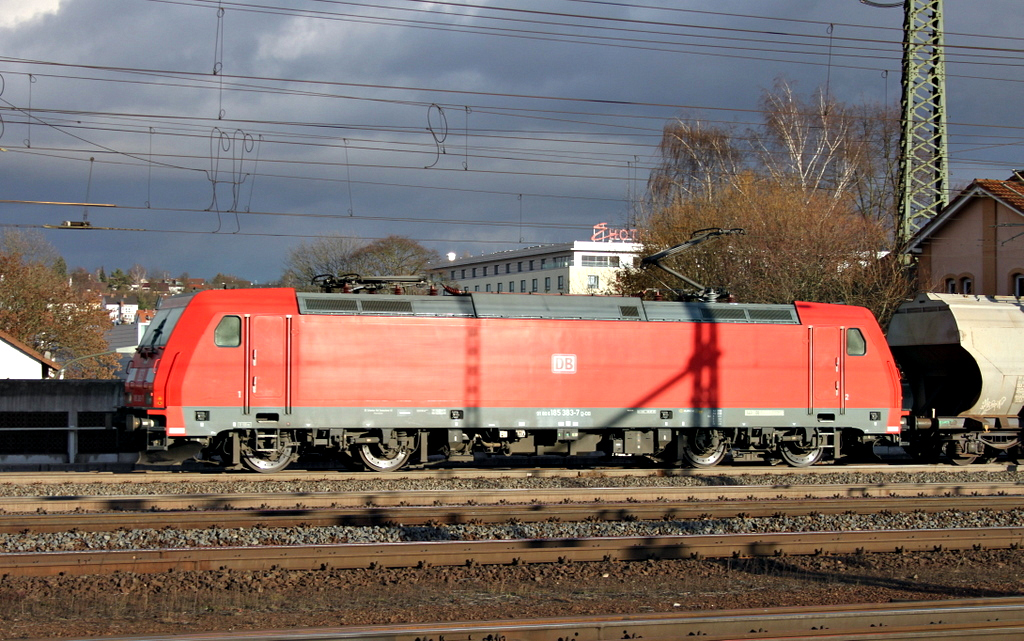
[898,0,949,243]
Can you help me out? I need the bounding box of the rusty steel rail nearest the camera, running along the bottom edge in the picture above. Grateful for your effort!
[48,597,1024,641]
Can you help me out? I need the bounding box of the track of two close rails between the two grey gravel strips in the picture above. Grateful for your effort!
[6,485,1024,533]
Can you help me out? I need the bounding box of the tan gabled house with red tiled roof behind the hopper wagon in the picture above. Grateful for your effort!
[909,170,1024,298]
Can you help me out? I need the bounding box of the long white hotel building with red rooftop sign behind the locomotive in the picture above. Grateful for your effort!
[430,237,640,294]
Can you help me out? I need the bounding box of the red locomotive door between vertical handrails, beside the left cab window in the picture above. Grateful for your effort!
[245,315,292,414]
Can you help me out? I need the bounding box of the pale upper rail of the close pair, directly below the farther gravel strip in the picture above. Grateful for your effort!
[0,482,1024,513]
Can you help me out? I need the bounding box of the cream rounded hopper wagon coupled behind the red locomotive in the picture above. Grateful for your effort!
[888,294,1024,464]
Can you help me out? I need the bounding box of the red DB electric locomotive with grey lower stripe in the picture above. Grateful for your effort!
[127,289,901,472]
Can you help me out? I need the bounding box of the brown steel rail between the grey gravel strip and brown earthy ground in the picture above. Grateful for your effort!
[0,527,1024,576]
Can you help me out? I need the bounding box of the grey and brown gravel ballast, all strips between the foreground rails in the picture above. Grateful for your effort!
[0,470,1024,640]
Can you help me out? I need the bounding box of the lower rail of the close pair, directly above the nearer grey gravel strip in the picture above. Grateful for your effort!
[6,496,1022,533]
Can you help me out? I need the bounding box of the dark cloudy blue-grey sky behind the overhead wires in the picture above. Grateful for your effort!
[0,0,1024,283]
